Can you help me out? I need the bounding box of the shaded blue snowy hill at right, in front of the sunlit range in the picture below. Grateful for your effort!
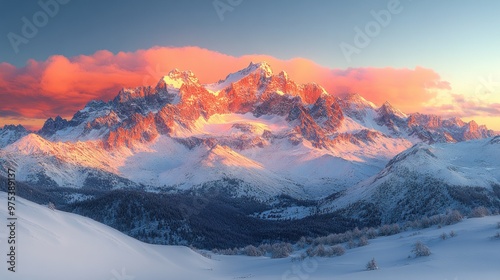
[323,136,500,221]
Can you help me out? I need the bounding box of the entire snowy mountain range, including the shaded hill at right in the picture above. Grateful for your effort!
[0,62,500,247]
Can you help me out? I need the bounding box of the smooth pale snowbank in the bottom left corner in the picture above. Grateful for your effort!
[0,192,214,280]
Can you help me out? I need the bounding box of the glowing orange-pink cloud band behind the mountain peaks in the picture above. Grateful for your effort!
[0,47,450,130]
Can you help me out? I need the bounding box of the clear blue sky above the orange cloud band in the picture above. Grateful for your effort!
[0,0,500,72]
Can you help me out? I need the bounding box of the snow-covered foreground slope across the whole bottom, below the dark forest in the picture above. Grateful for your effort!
[0,192,500,280]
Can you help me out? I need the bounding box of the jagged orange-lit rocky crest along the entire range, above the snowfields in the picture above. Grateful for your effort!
[26,63,495,152]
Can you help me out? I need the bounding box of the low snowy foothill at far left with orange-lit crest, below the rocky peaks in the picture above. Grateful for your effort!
[0,133,135,189]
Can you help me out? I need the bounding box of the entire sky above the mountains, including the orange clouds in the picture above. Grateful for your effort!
[0,0,500,130]
